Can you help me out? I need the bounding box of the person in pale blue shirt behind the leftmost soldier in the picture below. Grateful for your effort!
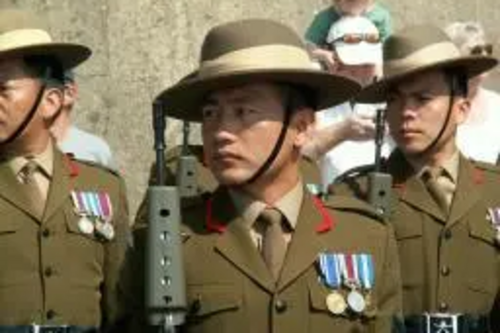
[50,70,115,169]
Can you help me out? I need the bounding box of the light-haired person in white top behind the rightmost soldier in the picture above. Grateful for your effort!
[445,22,500,164]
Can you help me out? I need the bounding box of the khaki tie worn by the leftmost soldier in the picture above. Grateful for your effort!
[19,160,45,218]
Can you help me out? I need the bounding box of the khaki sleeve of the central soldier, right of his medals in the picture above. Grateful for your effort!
[371,225,404,332]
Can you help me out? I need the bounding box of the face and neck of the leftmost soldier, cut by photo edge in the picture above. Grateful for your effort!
[0,59,62,154]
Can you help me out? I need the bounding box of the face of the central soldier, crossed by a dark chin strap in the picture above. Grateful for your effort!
[202,83,312,191]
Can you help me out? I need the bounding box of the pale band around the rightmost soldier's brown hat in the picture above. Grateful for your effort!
[384,42,460,77]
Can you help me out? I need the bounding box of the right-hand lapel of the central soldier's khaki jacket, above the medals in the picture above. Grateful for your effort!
[278,190,326,292]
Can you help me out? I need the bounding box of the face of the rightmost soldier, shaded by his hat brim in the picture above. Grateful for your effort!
[387,71,469,156]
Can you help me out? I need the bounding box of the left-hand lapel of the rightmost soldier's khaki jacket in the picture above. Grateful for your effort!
[387,151,446,223]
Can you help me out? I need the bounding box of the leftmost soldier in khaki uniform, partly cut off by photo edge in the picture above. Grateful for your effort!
[0,9,129,333]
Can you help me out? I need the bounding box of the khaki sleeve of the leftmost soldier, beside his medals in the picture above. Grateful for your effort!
[101,179,132,330]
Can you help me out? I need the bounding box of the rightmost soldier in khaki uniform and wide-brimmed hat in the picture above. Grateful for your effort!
[333,26,500,333]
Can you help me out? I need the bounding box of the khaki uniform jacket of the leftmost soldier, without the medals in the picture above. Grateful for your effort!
[0,150,130,327]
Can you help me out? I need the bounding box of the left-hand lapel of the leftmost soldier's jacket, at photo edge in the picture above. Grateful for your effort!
[0,162,38,222]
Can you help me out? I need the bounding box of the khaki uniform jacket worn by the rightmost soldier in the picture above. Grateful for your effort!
[333,151,500,330]
